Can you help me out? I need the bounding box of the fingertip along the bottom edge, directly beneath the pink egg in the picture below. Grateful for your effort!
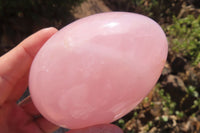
[66,124,123,133]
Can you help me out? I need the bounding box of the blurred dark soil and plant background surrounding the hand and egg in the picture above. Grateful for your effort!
[0,0,200,133]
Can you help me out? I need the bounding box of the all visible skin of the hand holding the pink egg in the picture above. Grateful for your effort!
[0,28,122,133]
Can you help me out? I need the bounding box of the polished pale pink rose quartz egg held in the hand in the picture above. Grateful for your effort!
[29,12,168,129]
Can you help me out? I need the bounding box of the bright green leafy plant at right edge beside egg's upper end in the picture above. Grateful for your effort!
[166,15,200,65]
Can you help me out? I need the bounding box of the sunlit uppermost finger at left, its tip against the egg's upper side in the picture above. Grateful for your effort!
[0,28,57,105]
